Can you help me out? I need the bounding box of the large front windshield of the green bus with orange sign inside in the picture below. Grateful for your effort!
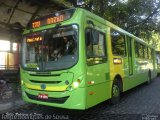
[22,25,78,71]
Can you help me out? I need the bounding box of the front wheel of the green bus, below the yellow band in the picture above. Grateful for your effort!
[110,78,121,105]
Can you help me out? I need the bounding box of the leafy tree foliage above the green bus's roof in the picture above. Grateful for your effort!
[65,0,160,49]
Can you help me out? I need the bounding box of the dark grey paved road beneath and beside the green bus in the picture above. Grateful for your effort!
[2,77,160,120]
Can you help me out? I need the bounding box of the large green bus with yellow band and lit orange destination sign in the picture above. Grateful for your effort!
[20,8,157,110]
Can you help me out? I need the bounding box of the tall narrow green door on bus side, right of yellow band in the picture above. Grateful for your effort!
[127,37,133,75]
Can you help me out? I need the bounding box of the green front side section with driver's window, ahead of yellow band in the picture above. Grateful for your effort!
[85,28,110,108]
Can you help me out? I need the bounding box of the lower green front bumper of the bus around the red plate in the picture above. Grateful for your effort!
[22,86,86,110]
